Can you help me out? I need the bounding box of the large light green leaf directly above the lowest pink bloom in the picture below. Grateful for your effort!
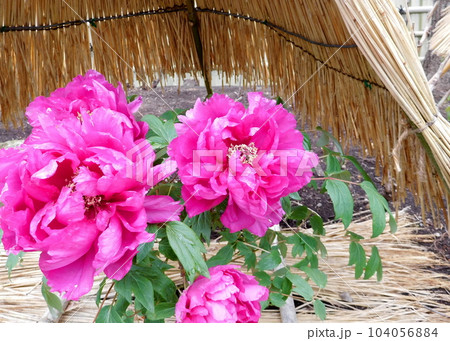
[166,221,209,282]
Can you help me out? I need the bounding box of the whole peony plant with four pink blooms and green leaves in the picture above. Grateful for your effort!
[0,70,395,323]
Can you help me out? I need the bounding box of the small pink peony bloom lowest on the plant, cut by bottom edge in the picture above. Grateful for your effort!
[175,265,269,323]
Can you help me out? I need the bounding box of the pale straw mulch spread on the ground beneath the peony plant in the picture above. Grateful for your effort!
[0,212,450,322]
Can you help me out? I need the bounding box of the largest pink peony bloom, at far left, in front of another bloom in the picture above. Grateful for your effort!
[0,72,182,300]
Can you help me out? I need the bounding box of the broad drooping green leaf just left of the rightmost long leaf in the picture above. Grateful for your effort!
[325,180,353,228]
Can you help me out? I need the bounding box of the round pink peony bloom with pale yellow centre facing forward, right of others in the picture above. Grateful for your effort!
[169,93,318,236]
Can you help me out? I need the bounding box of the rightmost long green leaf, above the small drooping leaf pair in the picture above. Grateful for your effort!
[361,181,397,238]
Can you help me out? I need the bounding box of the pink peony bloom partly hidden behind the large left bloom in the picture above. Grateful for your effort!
[26,70,148,140]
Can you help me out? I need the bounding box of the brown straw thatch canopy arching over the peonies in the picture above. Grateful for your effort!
[0,0,450,226]
